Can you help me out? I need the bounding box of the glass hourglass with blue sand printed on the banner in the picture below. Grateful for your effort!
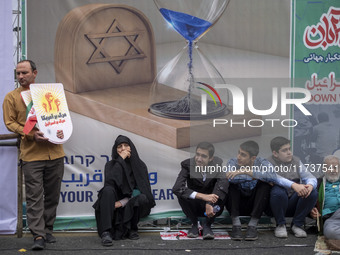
[149,0,229,120]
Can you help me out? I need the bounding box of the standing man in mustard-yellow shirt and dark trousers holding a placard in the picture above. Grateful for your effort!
[3,60,65,250]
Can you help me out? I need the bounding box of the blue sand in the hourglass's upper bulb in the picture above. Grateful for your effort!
[160,8,212,42]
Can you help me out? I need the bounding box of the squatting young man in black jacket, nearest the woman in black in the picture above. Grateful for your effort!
[172,142,228,239]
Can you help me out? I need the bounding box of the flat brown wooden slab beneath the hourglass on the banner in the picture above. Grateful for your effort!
[66,84,261,148]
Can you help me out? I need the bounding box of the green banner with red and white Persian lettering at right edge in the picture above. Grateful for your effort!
[291,0,340,169]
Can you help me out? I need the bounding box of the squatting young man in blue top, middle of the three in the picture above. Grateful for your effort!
[226,141,276,241]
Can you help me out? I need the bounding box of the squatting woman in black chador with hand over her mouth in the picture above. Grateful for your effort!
[93,135,155,246]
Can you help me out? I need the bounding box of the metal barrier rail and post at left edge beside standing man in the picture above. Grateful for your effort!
[0,133,23,238]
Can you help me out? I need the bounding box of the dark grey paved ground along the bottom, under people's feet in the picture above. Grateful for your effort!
[0,230,317,255]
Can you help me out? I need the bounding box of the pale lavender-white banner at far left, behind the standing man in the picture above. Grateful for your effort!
[0,1,18,234]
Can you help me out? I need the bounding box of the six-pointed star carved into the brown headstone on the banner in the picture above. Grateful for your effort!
[85,19,146,74]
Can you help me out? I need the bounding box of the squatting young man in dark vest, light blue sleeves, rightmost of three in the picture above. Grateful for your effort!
[268,136,318,238]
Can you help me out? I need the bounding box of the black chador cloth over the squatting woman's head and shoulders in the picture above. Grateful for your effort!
[105,135,155,208]
